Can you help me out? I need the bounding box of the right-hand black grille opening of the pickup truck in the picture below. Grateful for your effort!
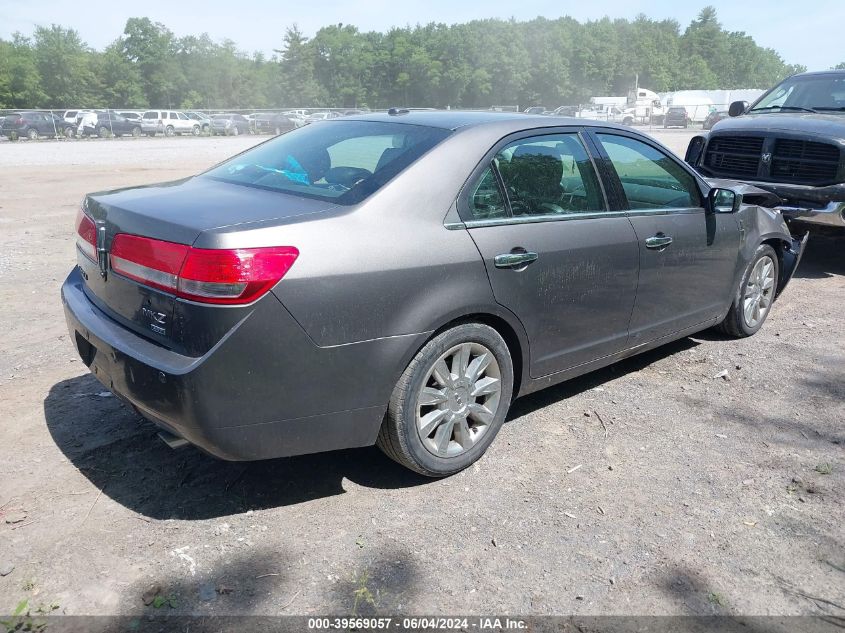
[771,139,839,185]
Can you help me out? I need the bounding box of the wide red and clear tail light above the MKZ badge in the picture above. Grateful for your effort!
[111,233,299,304]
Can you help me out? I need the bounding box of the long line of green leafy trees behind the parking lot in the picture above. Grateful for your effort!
[0,7,824,109]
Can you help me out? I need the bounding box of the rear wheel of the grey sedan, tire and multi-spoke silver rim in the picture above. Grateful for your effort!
[377,323,513,477]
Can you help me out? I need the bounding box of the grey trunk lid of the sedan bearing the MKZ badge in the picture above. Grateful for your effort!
[77,176,336,355]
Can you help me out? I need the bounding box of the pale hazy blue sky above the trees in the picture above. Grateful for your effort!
[0,0,845,70]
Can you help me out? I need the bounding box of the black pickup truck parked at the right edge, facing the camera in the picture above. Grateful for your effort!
[686,70,845,227]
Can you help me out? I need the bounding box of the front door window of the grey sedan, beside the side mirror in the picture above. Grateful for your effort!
[597,134,701,210]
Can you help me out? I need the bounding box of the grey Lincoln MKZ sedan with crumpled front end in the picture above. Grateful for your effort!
[61,110,803,477]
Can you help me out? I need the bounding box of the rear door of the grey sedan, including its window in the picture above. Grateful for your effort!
[459,128,638,377]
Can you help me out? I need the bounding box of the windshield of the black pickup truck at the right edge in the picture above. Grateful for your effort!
[749,75,845,112]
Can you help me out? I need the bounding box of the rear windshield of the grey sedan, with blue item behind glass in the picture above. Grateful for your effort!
[205,121,449,204]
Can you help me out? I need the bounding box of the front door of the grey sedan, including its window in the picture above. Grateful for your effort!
[591,129,740,347]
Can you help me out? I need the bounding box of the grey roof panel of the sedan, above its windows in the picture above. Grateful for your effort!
[343,110,630,130]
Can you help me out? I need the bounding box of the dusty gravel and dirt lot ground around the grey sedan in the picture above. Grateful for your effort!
[0,131,845,616]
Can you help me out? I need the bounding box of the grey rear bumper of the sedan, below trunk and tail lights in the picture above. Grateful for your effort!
[62,268,415,460]
